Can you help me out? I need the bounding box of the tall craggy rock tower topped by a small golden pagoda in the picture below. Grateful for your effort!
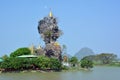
[38,12,62,60]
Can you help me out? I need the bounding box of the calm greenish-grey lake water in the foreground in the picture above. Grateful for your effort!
[0,66,120,80]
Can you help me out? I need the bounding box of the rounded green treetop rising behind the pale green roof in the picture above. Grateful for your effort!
[10,48,31,57]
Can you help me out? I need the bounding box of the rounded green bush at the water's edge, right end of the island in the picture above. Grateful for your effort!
[80,58,93,69]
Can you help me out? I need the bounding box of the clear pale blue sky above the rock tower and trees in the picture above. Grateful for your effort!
[0,0,120,57]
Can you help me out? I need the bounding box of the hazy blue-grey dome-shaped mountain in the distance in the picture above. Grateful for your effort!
[75,47,94,60]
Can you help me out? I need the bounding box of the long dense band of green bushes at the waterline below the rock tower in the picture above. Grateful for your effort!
[0,56,61,71]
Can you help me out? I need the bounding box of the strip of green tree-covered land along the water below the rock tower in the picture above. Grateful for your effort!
[0,48,120,72]
